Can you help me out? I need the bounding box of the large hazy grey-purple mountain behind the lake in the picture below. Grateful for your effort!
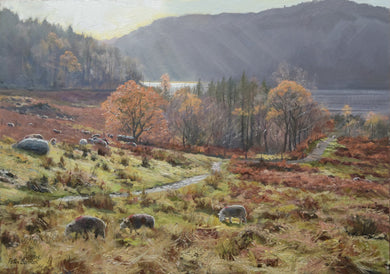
[114,0,390,89]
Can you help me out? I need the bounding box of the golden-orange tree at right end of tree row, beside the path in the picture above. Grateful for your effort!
[267,81,328,152]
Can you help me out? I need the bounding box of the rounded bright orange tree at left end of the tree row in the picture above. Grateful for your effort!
[102,80,167,141]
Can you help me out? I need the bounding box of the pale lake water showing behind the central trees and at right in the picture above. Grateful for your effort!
[144,82,390,115]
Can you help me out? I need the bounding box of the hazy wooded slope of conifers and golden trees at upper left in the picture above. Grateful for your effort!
[0,9,142,89]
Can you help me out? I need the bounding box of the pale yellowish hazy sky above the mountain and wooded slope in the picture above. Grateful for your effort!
[0,0,390,39]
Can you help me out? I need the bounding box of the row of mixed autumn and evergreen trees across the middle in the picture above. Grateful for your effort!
[102,70,330,153]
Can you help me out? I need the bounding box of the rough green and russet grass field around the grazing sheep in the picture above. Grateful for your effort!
[0,92,390,273]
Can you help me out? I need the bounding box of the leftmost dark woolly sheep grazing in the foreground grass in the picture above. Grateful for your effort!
[65,216,106,240]
